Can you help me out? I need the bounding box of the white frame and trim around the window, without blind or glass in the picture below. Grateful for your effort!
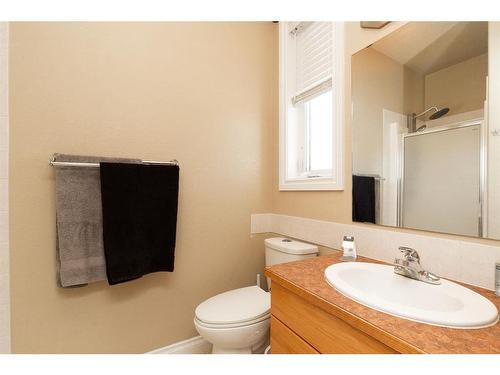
[279,22,345,191]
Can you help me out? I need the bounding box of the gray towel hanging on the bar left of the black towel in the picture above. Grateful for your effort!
[54,154,140,287]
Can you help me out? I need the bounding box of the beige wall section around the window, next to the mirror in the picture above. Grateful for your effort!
[272,22,500,245]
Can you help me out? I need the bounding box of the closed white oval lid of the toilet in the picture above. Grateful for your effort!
[195,286,271,324]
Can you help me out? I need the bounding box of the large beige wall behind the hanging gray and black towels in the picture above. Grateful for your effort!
[10,22,277,353]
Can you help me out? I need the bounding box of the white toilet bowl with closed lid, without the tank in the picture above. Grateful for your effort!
[194,286,271,354]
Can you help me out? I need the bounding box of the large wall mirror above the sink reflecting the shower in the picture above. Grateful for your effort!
[351,22,500,239]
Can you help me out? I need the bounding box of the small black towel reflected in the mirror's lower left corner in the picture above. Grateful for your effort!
[352,175,375,224]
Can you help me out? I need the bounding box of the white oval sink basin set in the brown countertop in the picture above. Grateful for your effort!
[325,262,498,329]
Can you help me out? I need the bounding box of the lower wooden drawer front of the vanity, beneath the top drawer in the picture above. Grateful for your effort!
[271,316,319,354]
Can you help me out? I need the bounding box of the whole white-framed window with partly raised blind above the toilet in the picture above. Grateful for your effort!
[280,22,344,190]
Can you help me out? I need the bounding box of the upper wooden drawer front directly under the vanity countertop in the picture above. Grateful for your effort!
[271,283,396,354]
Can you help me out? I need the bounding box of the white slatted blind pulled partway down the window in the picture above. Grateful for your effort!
[290,22,333,105]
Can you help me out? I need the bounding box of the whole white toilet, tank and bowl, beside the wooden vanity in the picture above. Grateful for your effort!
[194,237,318,354]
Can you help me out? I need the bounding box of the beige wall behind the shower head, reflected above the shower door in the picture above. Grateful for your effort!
[425,53,488,116]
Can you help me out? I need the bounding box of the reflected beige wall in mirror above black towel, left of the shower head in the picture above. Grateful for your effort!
[351,48,424,175]
